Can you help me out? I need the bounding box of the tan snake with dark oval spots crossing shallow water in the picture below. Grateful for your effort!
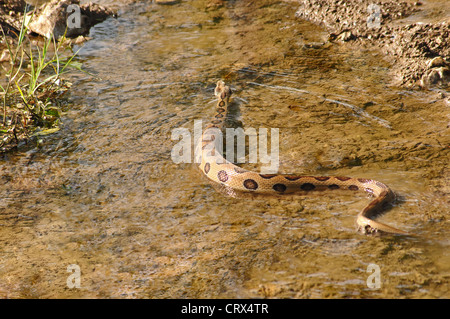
[196,80,409,235]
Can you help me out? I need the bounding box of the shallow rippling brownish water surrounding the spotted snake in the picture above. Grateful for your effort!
[0,0,450,298]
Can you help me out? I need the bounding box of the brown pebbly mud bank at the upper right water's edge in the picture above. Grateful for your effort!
[296,0,450,87]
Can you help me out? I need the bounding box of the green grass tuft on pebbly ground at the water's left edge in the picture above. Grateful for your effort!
[0,8,82,152]
